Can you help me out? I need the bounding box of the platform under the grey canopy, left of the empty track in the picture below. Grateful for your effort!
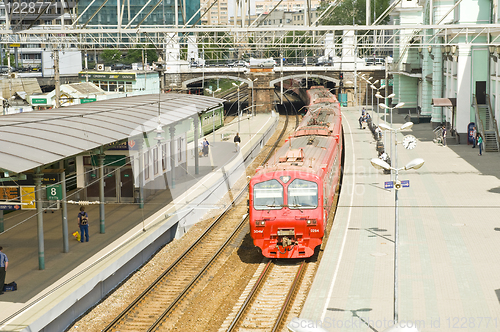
[0,113,278,331]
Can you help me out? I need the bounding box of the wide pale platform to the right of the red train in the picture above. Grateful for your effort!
[296,108,500,332]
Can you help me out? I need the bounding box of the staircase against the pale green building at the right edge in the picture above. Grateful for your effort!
[474,95,500,152]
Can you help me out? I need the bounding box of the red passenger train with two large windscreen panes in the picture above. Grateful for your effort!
[249,87,342,258]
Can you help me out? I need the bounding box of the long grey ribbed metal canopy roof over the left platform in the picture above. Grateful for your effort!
[0,93,223,173]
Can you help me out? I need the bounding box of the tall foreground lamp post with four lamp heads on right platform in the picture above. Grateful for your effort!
[370,122,425,325]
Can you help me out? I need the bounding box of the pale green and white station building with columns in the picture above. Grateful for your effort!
[388,0,500,151]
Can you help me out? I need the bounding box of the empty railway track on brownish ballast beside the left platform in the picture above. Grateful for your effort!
[103,109,298,331]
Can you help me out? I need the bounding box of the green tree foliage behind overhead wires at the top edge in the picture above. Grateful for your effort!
[319,0,389,25]
